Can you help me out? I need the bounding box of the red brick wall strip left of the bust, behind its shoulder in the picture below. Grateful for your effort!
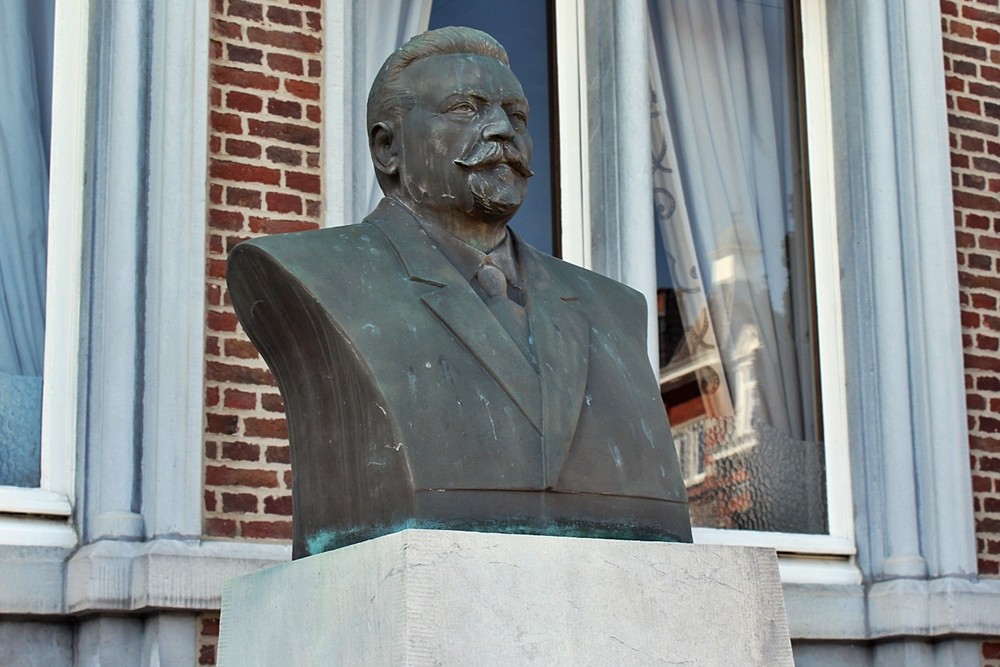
[198,0,322,665]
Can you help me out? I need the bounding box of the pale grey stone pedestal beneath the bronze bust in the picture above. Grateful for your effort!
[219,530,792,667]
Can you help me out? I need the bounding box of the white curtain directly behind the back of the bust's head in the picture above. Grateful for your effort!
[364,0,431,212]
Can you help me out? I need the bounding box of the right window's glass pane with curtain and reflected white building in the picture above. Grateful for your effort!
[649,0,827,533]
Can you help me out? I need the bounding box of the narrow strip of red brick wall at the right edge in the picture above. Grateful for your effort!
[941,0,1000,667]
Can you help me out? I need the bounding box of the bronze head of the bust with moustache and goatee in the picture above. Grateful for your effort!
[368,28,532,240]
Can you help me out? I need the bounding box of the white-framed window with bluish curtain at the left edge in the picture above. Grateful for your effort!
[0,0,89,546]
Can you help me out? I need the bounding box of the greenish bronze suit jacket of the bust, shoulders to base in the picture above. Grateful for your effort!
[228,199,691,557]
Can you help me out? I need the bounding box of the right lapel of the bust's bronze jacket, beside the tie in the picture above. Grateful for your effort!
[515,243,590,487]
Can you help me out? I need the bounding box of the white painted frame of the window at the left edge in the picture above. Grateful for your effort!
[0,0,90,547]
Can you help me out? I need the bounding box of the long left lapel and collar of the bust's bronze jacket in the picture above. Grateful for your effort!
[365,199,544,433]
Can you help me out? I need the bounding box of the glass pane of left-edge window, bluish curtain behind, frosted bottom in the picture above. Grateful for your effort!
[0,0,53,486]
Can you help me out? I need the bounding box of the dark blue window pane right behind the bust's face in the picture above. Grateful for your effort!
[430,0,558,254]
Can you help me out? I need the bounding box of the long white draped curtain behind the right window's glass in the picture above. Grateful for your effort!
[649,0,823,532]
